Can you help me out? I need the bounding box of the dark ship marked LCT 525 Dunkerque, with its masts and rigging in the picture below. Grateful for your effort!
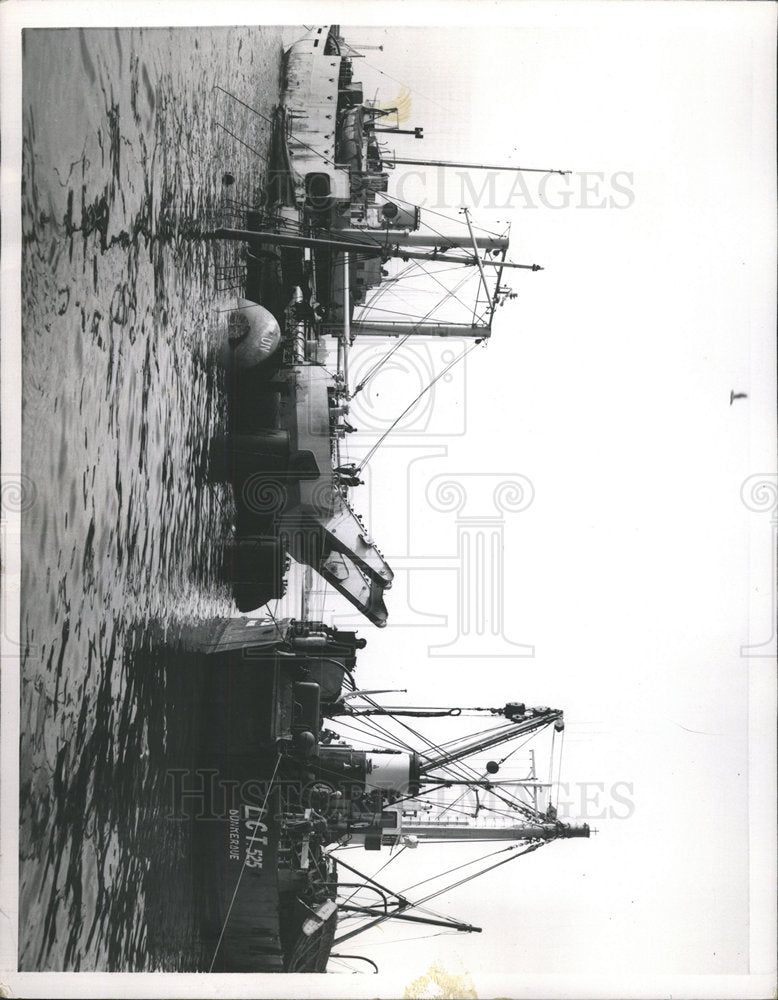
[183,617,590,973]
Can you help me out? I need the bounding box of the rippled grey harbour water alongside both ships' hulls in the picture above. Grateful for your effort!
[19,28,282,970]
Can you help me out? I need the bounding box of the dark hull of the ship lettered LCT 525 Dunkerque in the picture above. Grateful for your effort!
[186,619,348,973]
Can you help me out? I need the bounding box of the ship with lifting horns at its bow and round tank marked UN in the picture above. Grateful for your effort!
[208,26,540,627]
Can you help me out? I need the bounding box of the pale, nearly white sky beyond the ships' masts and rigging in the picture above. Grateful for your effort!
[3,3,776,997]
